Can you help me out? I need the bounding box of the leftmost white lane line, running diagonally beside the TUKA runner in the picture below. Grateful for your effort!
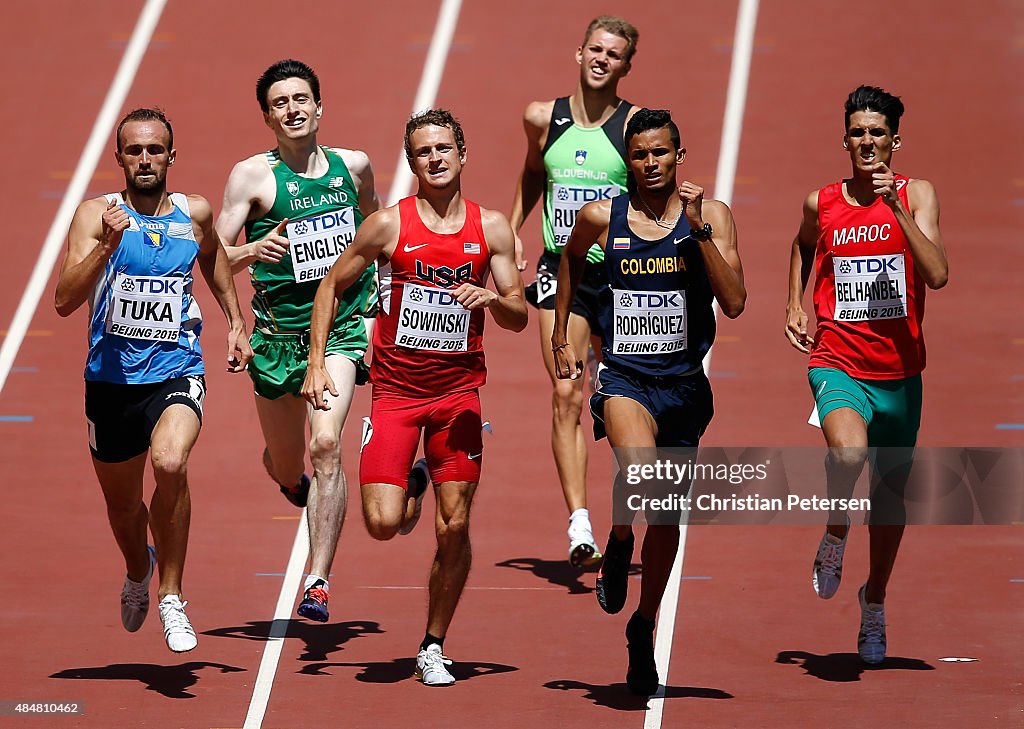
[0,0,167,392]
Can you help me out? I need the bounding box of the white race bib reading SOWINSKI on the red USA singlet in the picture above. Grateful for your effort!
[394,284,469,352]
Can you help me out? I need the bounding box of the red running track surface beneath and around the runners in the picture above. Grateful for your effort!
[0,0,1024,729]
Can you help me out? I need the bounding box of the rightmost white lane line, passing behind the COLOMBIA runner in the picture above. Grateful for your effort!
[643,0,758,729]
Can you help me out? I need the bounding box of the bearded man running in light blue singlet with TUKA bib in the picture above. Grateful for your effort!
[54,109,252,653]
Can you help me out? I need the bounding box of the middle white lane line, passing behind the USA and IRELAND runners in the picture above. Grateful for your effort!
[244,0,462,729]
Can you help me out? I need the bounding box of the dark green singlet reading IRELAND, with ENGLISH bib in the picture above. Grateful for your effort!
[246,146,377,333]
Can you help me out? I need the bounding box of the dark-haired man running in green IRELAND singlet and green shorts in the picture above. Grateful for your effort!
[217,59,380,623]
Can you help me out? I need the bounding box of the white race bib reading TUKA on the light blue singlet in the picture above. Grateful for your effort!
[106,272,185,342]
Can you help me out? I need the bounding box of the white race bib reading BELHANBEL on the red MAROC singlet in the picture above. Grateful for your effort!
[833,253,906,321]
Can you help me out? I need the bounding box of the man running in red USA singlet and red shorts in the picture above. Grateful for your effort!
[302,110,526,686]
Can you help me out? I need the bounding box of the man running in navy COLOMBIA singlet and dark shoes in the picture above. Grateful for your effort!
[551,109,746,695]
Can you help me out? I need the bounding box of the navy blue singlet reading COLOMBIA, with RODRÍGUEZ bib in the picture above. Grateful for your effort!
[598,195,715,377]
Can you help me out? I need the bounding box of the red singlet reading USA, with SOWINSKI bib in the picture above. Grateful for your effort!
[371,198,490,397]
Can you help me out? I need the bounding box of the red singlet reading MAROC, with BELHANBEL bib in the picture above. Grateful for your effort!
[808,175,925,380]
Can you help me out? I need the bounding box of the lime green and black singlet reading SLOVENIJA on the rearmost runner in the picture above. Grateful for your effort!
[542,96,633,263]
